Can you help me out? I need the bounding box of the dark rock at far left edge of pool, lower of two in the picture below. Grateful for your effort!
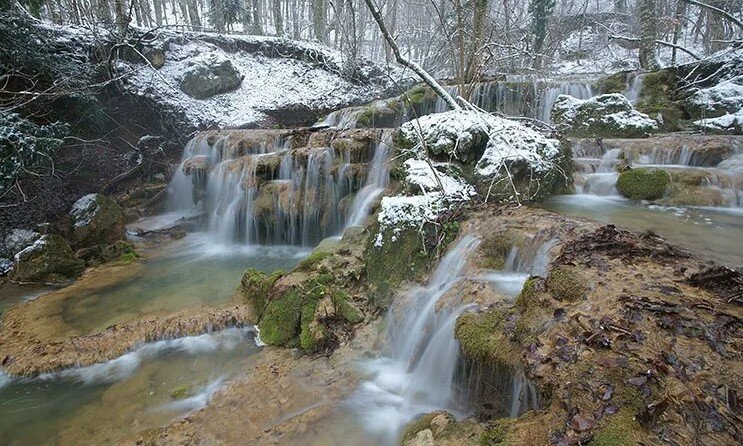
[12,234,85,283]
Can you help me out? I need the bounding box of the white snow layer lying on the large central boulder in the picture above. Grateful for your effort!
[375,110,560,242]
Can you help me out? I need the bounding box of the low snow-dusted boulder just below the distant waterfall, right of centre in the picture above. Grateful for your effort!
[551,93,658,138]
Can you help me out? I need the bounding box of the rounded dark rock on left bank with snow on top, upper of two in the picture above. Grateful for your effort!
[70,194,126,248]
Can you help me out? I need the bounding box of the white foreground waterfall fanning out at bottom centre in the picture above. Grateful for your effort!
[349,236,479,443]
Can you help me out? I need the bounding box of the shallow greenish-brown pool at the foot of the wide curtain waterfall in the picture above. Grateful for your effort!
[62,233,309,334]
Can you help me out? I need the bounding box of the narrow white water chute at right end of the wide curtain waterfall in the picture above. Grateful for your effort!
[346,131,392,227]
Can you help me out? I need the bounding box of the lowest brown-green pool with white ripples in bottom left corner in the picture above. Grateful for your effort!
[0,328,260,446]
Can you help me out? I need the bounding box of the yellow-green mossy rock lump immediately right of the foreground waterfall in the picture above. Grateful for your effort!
[454,308,520,366]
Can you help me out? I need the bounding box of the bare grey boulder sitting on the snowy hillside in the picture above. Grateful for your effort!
[181,54,243,99]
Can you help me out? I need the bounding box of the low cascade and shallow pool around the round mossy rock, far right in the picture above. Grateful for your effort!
[543,137,743,266]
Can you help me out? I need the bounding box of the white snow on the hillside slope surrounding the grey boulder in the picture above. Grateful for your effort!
[122,31,400,127]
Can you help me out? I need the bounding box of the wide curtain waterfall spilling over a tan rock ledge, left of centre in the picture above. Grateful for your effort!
[170,129,391,246]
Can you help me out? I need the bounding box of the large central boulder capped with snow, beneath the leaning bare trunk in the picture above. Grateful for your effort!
[376,110,572,240]
